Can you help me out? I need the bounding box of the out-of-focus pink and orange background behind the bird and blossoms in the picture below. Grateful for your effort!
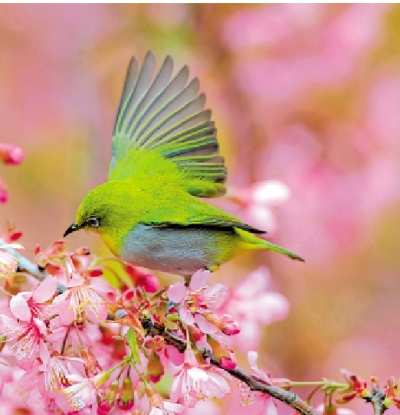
[0,4,400,414]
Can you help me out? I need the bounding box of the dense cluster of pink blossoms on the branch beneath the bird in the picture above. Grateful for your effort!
[0,229,288,415]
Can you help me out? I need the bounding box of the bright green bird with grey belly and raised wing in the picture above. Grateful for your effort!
[64,52,303,277]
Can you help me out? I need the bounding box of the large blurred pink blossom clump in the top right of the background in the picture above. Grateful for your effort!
[222,4,387,108]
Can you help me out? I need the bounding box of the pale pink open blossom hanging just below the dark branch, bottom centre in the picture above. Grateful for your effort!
[170,350,230,408]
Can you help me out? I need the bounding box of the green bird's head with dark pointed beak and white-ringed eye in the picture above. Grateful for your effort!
[64,182,132,237]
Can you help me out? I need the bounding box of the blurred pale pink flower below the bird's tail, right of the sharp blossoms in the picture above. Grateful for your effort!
[223,267,289,352]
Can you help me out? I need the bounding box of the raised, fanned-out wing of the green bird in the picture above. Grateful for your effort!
[109,52,226,197]
